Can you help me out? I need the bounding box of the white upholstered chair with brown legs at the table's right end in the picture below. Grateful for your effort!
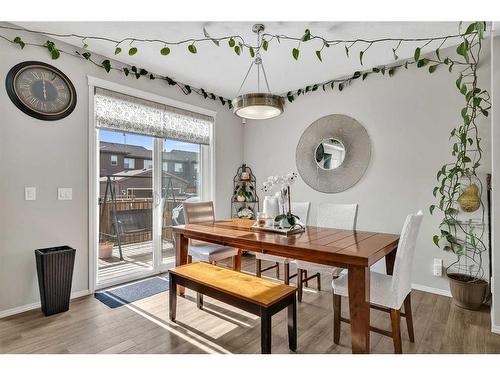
[332,211,423,354]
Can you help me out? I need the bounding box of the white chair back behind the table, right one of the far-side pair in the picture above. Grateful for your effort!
[316,203,358,230]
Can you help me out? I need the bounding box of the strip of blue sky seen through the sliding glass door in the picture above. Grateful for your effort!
[99,129,199,152]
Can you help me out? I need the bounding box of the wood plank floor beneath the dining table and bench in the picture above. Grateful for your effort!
[0,255,500,354]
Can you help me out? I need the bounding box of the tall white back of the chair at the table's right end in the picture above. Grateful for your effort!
[392,211,424,303]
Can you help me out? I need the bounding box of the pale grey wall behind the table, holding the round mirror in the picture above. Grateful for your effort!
[244,41,491,293]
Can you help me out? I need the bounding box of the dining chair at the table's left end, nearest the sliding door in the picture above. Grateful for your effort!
[183,201,241,309]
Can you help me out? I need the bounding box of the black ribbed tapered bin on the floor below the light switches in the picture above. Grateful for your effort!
[35,246,76,316]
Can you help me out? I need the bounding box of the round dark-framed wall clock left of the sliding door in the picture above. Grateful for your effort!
[5,61,76,121]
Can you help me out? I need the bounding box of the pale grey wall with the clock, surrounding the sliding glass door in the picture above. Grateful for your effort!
[0,25,243,314]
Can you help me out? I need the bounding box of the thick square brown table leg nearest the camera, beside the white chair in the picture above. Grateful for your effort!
[348,267,370,354]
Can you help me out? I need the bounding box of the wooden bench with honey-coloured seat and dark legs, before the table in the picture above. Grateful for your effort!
[169,262,297,354]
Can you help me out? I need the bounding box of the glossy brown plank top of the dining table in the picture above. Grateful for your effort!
[173,219,399,268]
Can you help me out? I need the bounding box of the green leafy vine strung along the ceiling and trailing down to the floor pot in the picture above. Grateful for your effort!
[0,22,491,280]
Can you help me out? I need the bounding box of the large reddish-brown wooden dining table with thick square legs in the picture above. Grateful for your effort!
[172,219,399,353]
